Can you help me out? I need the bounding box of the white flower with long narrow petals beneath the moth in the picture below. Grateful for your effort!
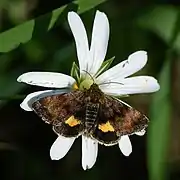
[17,11,160,170]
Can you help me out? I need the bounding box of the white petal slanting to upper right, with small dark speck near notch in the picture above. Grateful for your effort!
[97,51,147,83]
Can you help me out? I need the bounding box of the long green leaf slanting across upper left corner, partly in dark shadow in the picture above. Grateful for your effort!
[0,0,105,52]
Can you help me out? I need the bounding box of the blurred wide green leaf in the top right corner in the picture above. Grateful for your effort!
[138,5,179,44]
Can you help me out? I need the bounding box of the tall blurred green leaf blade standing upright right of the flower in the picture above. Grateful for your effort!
[148,56,171,180]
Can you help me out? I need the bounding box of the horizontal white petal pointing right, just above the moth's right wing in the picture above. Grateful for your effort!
[100,76,160,95]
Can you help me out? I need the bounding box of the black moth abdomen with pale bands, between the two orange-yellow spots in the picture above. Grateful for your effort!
[85,103,99,130]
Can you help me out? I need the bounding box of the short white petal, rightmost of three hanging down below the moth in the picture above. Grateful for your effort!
[119,135,132,156]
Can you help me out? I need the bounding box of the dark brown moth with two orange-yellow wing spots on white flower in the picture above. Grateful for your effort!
[32,83,149,146]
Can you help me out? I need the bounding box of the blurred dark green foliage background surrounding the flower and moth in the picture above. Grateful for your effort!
[0,0,180,180]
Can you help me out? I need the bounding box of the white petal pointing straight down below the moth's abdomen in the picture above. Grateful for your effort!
[82,136,98,170]
